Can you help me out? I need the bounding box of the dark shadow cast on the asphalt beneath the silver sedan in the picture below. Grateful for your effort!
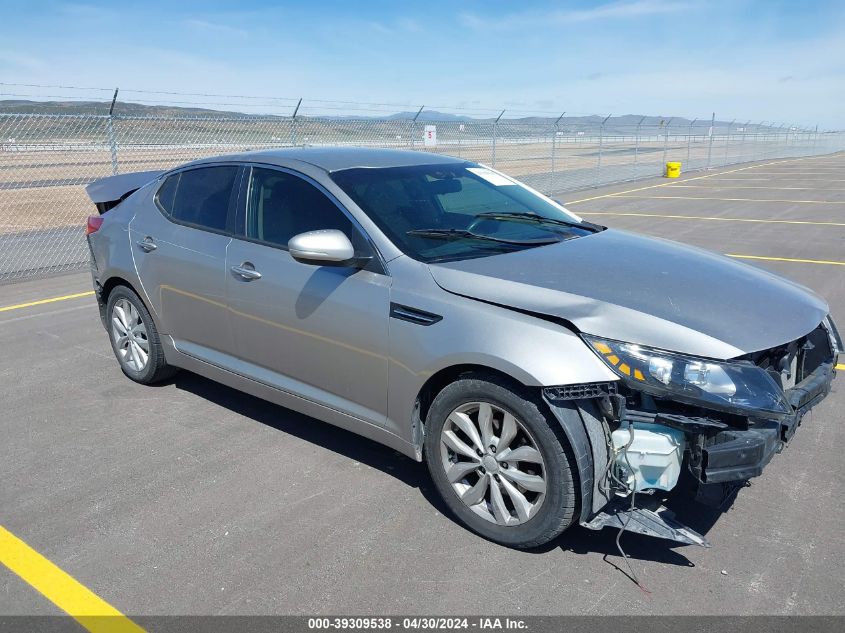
[172,371,733,575]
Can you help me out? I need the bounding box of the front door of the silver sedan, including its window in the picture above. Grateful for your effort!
[226,167,390,424]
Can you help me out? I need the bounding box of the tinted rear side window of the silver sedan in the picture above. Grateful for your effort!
[156,165,238,231]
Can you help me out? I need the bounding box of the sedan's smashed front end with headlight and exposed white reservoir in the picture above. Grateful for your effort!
[543,317,842,546]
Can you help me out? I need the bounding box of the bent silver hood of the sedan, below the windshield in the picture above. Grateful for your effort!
[429,229,828,359]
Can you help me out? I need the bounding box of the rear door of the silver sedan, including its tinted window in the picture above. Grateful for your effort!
[129,165,242,364]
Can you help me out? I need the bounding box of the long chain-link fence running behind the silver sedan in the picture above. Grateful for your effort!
[0,113,845,281]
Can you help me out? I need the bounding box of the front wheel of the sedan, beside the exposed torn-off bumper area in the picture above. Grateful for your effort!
[425,375,578,549]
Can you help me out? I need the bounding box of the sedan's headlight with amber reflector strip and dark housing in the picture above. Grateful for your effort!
[584,335,792,415]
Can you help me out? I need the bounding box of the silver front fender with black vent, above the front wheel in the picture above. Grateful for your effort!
[387,258,618,450]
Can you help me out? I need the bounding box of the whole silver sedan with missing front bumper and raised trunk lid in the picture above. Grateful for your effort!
[87,147,842,548]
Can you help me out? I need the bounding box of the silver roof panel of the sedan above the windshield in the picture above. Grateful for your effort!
[185,146,466,172]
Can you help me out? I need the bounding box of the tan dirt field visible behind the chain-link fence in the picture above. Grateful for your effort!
[0,137,780,235]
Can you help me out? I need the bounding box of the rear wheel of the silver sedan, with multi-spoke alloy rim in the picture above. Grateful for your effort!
[106,286,177,385]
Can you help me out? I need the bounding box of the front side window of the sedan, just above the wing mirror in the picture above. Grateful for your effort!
[246,167,363,248]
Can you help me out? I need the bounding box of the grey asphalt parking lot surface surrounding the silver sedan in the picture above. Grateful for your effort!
[0,154,845,616]
